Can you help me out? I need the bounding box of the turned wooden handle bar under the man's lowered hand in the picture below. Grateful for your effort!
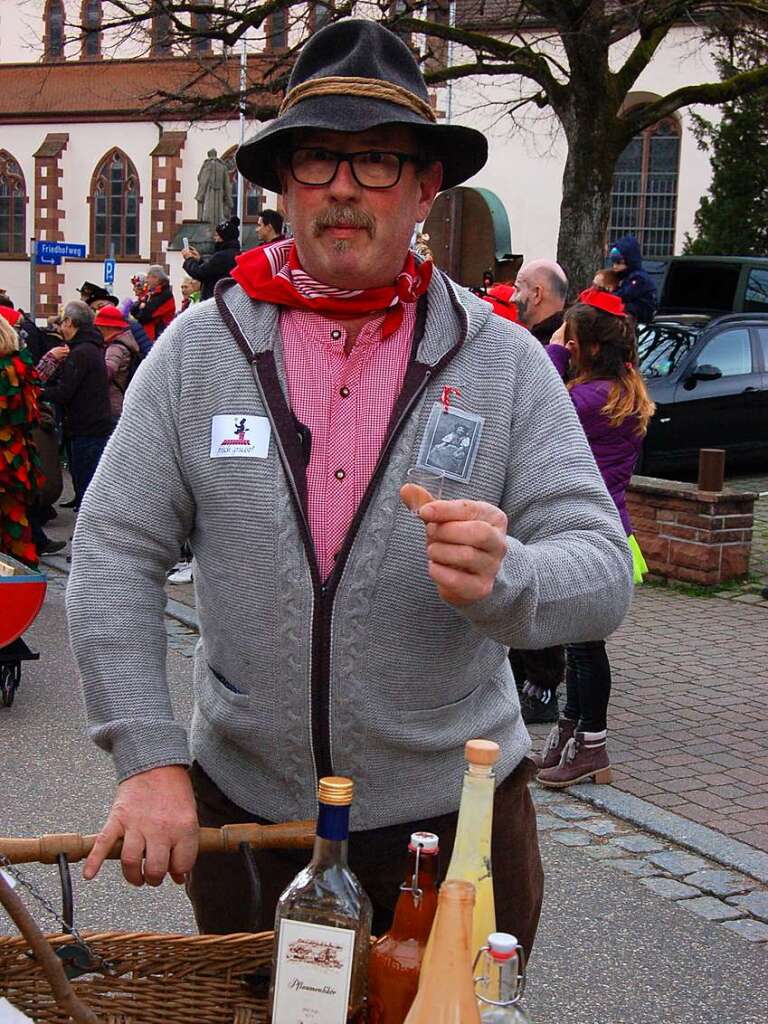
[0,821,314,864]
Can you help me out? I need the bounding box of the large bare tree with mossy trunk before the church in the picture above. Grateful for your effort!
[55,0,768,284]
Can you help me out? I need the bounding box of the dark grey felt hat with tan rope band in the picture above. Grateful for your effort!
[237,18,487,193]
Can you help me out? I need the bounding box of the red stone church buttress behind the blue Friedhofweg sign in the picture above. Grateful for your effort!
[30,132,70,316]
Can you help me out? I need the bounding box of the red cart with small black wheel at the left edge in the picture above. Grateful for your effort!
[0,552,47,708]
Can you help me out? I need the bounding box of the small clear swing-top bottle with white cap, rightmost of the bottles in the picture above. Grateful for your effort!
[474,932,530,1024]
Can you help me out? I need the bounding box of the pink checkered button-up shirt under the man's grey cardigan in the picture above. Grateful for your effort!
[280,302,416,580]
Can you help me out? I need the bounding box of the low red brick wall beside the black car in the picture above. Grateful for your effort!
[627,476,757,587]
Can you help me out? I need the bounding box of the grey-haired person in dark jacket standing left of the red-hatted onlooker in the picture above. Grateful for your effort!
[42,302,112,507]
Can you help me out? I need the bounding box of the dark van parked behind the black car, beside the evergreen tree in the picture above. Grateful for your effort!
[656,256,768,316]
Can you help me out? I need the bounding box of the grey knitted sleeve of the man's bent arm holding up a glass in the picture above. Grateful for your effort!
[459,335,632,650]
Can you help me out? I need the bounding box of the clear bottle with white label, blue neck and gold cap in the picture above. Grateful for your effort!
[269,776,372,1024]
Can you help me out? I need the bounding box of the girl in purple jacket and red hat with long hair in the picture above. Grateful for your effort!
[535,288,654,788]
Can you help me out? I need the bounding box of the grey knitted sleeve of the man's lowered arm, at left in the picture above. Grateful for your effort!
[67,327,195,780]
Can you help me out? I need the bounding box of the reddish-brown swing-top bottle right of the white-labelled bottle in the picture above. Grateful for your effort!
[368,831,439,1024]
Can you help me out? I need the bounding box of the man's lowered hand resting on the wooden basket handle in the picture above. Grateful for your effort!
[83,765,198,886]
